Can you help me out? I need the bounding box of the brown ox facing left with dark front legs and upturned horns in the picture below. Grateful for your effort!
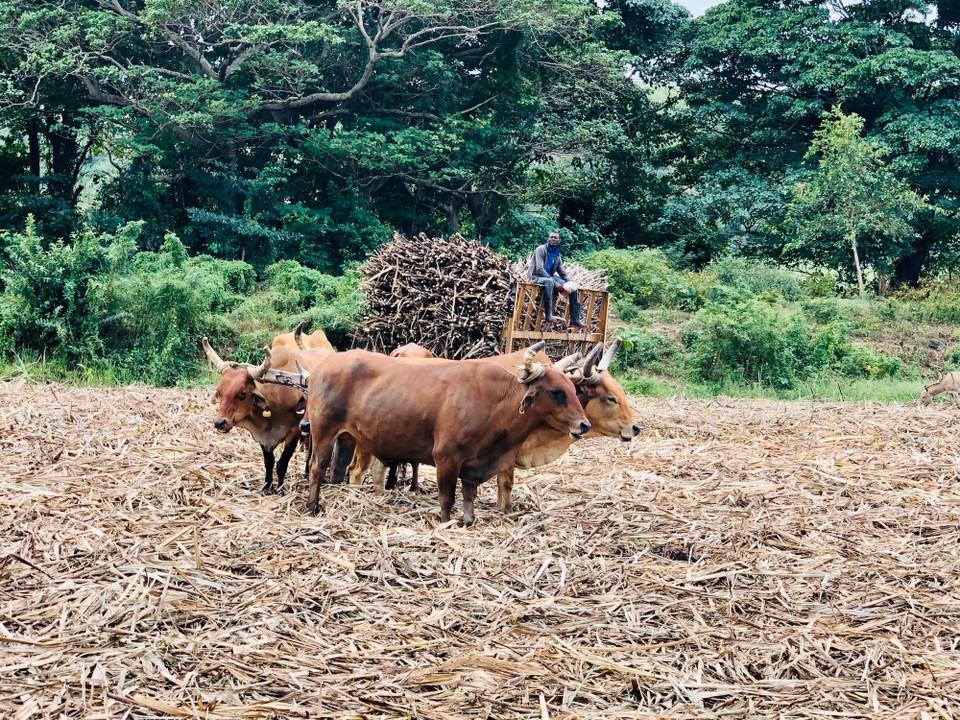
[202,338,330,492]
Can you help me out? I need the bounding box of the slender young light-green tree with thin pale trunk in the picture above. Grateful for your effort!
[786,108,926,297]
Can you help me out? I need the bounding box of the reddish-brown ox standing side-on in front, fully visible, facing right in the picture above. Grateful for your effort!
[262,345,590,525]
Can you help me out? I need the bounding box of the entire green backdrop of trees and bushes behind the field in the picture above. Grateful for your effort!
[0,0,960,399]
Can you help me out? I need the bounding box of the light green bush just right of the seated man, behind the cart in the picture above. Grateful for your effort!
[583,249,700,310]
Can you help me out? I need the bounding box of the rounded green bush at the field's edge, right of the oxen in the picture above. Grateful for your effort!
[683,300,798,389]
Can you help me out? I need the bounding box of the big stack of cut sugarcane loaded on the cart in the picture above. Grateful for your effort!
[355,234,606,360]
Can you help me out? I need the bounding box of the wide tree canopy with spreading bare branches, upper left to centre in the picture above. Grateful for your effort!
[0,0,676,267]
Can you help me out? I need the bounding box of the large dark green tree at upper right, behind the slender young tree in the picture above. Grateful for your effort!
[664,0,960,283]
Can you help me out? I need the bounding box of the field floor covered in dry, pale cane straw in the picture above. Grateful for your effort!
[0,381,960,720]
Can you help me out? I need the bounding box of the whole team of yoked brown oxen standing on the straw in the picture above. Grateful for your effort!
[202,323,640,525]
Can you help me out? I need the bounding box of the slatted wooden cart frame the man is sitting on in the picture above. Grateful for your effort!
[502,282,610,360]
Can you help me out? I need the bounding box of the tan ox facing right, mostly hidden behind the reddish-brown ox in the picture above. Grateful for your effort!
[350,338,640,513]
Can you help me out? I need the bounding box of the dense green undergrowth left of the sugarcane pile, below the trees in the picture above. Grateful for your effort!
[0,219,362,384]
